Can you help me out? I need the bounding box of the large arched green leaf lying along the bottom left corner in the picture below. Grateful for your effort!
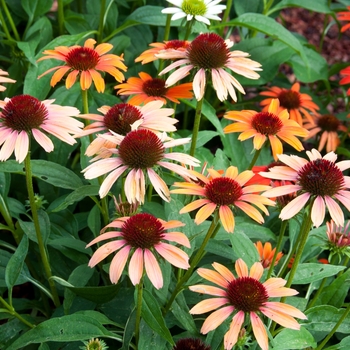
[7,314,121,350]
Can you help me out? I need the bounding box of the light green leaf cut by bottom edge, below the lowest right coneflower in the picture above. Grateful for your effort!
[272,327,317,350]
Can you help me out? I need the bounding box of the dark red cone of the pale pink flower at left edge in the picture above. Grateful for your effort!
[0,95,49,132]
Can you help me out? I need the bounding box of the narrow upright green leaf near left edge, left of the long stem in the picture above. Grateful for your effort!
[5,235,29,288]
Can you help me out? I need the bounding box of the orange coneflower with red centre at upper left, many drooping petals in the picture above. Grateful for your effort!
[38,39,127,92]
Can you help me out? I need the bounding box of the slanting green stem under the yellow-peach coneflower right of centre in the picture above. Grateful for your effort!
[163,211,220,316]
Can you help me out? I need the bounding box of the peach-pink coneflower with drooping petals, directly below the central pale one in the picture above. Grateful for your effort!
[86,213,190,289]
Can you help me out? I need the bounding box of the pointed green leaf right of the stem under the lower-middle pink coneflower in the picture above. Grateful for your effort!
[141,289,175,345]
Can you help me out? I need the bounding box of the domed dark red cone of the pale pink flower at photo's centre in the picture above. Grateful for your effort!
[119,129,164,169]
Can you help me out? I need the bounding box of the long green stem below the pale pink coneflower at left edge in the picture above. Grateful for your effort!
[24,151,60,307]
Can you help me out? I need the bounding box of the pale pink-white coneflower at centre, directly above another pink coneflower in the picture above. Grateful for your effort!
[83,129,199,203]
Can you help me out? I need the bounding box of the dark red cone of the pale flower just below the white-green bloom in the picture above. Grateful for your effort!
[188,33,230,69]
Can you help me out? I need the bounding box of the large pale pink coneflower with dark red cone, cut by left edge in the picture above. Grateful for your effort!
[0,95,84,163]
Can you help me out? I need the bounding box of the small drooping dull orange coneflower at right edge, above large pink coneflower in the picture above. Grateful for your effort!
[304,114,347,152]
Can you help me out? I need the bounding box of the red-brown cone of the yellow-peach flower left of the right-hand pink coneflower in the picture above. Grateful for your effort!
[205,177,243,205]
